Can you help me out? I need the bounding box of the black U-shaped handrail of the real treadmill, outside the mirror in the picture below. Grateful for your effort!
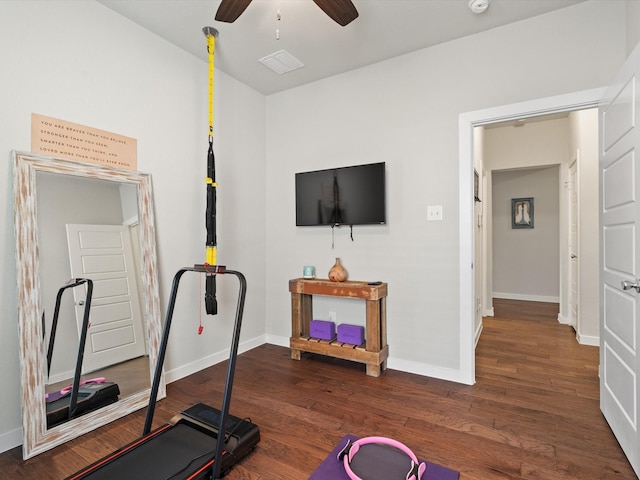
[142,265,247,480]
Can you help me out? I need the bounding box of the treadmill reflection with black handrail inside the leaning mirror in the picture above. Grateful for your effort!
[43,278,120,428]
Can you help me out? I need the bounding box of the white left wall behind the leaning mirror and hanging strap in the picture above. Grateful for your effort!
[0,0,266,451]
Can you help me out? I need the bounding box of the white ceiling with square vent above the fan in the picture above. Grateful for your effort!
[98,0,584,95]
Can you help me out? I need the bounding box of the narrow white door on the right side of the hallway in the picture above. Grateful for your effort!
[569,158,580,332]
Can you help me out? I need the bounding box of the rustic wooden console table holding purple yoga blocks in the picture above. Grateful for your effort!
[289,278,389,377]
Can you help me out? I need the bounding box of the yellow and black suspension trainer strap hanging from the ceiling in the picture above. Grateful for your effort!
[202,27,218,315]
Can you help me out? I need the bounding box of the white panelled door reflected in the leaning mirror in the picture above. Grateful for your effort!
[67,224,145,372]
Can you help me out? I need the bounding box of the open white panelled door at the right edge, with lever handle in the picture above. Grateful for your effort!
[599,42,640,475]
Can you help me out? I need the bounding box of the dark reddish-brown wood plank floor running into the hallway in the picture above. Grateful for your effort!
[0,303,636,480]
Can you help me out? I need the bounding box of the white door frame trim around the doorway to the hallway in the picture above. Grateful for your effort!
[458,88,605,385]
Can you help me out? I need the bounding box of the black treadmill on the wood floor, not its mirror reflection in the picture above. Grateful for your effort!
[67,264,260,480]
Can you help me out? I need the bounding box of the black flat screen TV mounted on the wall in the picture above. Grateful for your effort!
[296,162,387,227]
